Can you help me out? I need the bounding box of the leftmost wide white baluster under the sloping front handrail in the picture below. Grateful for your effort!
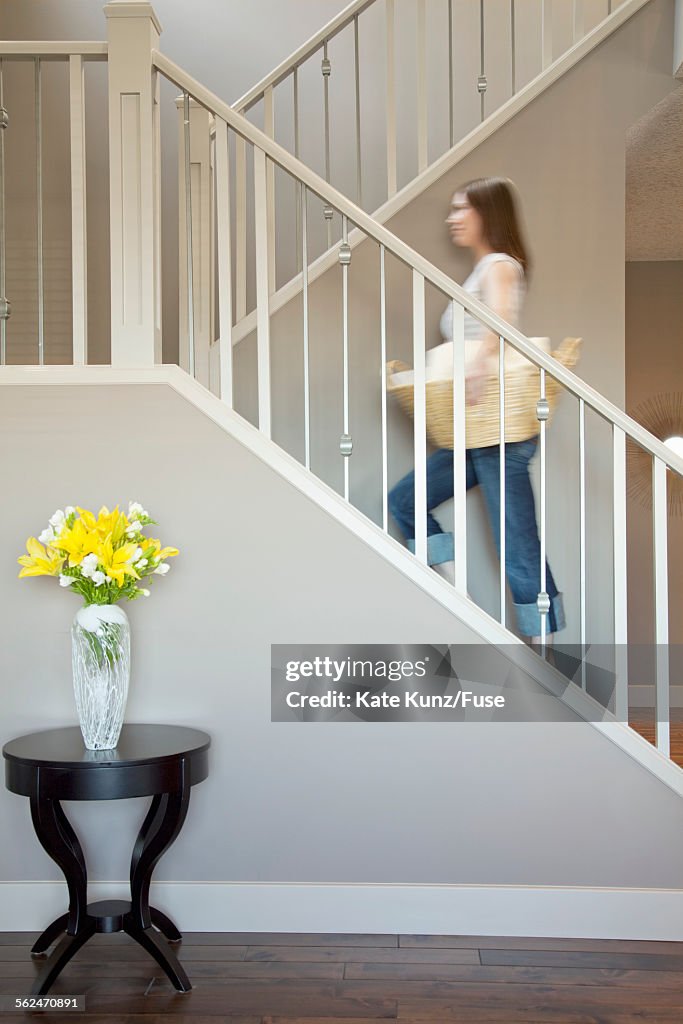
[214,115,232,409]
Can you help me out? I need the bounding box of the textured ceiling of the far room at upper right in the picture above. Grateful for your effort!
[626,83,683,261]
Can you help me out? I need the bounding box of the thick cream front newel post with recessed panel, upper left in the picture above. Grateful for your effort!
[104,0,162,367]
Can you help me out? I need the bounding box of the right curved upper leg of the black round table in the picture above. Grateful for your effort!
[130,761,189,933]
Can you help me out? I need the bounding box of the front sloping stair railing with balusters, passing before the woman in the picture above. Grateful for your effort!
[153,51,683,754]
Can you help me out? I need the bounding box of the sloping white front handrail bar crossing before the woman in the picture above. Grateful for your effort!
[152,50,683,476]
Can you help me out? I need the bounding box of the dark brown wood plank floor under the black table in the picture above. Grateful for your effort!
[0,932,683,1024]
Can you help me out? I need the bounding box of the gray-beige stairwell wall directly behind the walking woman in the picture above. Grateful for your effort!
[233,0,680,643]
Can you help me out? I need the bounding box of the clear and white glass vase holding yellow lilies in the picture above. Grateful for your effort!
[71,604,130,751]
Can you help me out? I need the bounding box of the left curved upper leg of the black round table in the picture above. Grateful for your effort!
[31,781,88,942]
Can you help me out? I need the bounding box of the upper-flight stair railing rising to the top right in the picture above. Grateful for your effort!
[228,0,621,322]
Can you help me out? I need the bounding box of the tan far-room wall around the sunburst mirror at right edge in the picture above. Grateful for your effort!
[626,260,683,644]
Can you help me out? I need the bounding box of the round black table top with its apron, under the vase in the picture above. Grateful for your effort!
[2,724,211,800]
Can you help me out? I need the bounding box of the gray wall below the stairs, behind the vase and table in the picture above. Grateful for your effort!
[0,385,683,888]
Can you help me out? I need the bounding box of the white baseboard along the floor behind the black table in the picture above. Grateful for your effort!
[0,882,683,942]
